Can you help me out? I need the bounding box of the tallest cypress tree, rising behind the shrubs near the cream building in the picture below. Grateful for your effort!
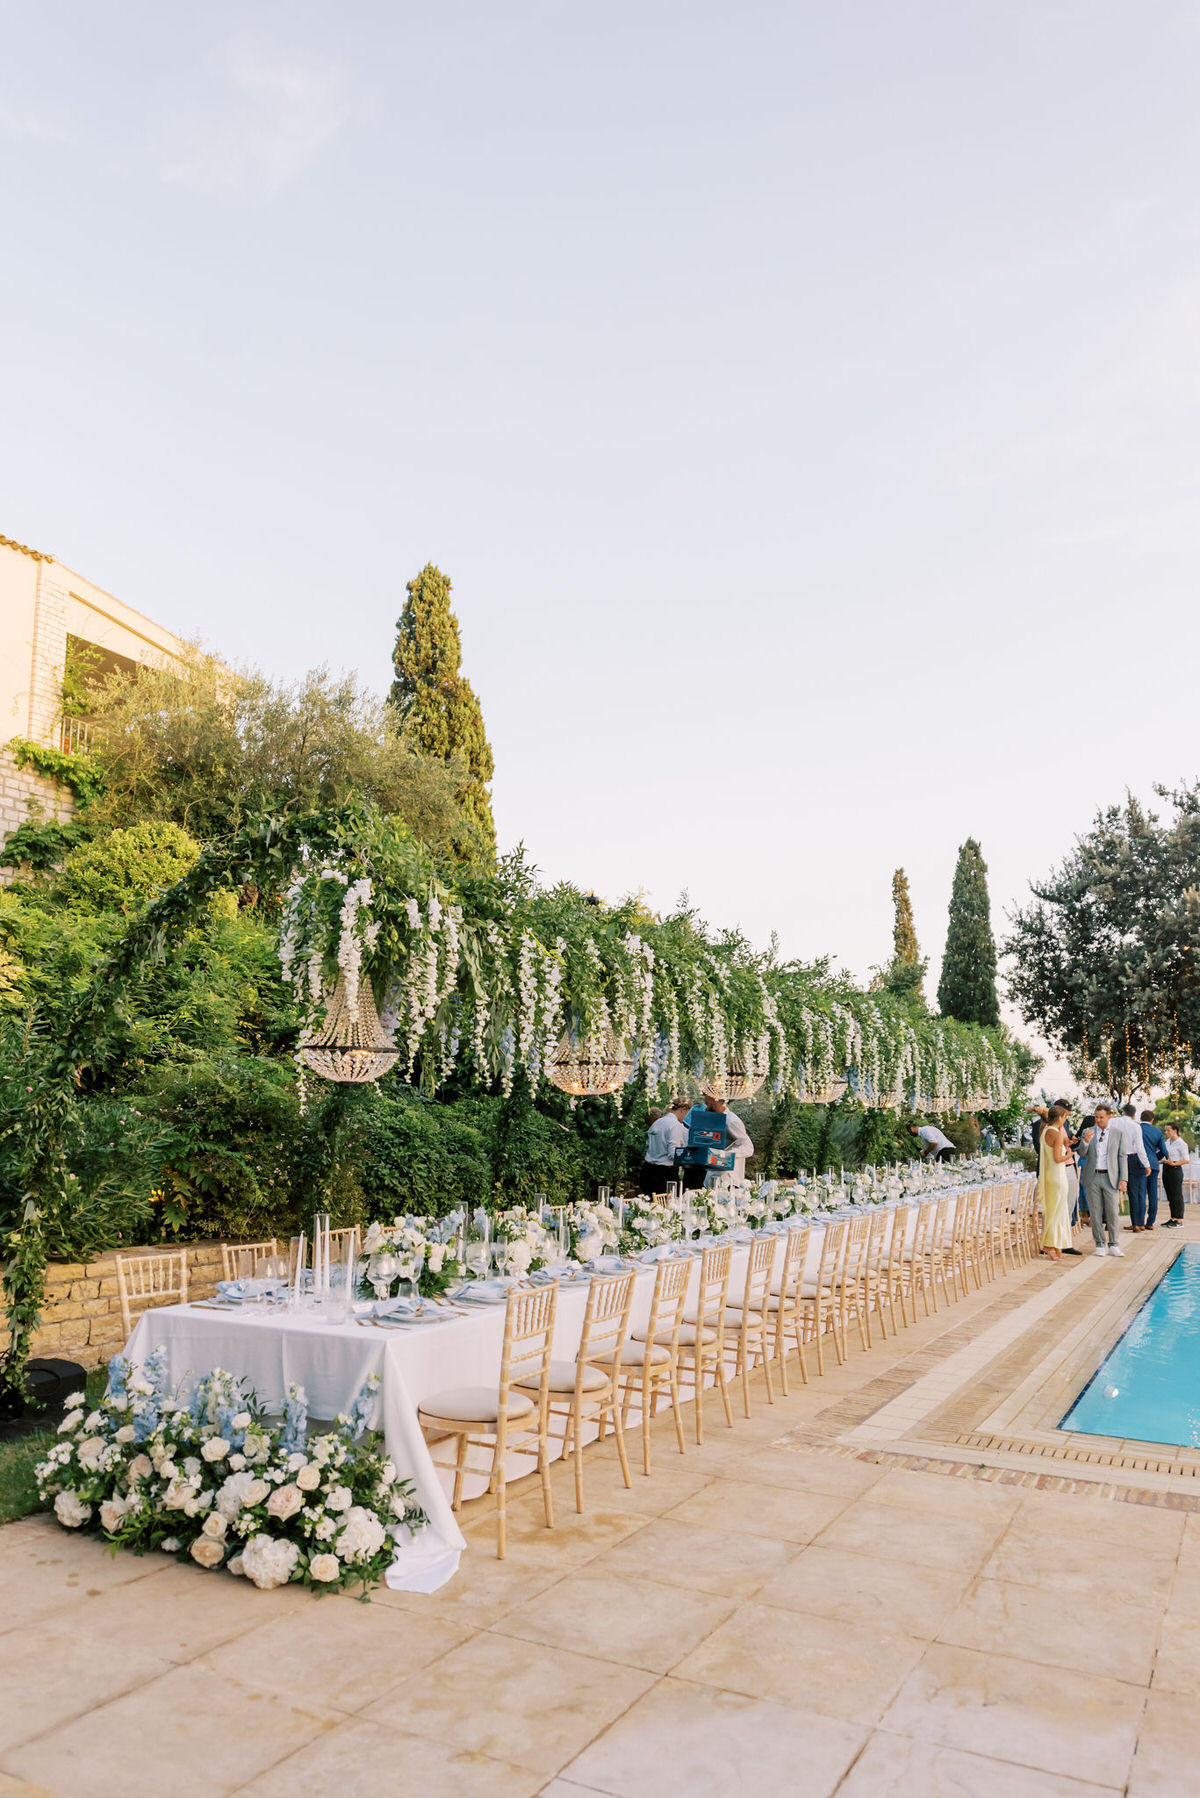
[390,563,497,849]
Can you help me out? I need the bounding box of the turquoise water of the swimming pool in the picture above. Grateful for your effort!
[1058,1244,1200,1447]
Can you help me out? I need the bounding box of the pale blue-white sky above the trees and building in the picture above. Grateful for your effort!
[0,0,1200,1071]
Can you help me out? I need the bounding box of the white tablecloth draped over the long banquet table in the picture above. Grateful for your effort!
[126,1187,1014,1591]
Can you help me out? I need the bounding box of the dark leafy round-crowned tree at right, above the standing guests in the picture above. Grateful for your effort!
[1006,786,1200,1095]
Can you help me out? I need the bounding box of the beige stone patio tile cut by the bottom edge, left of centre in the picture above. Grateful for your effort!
[239,1717,542,1798]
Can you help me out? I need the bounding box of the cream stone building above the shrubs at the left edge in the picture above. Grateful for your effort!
[0,536,184,841]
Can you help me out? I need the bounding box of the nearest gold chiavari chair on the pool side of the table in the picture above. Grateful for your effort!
[417,1286,558,1561]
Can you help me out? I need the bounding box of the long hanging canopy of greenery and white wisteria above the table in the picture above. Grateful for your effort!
[268,818,1018,1111]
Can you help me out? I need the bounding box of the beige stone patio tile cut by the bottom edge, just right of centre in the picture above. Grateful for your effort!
[565,1679,865,1798]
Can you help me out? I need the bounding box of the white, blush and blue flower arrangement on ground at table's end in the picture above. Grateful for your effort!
[36,1349,426,1591]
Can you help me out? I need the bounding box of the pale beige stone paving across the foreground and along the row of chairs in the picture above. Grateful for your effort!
[0,1237,1200,1798]
